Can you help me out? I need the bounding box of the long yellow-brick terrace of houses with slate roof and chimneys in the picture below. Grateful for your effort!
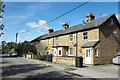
[31,13,120,65]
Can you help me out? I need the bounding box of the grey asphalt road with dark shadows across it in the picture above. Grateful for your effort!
[0,54,81,80]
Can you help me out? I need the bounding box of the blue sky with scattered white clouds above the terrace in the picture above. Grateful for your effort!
[0,2,118,42]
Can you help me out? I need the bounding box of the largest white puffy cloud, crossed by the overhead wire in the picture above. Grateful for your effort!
[26,20,49,34]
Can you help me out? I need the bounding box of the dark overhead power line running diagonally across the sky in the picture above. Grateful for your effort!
[21,0,92,33]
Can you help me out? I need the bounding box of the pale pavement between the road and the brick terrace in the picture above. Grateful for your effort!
[20,57,120,79]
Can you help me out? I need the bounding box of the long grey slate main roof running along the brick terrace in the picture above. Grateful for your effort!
[30,14,115,42]
